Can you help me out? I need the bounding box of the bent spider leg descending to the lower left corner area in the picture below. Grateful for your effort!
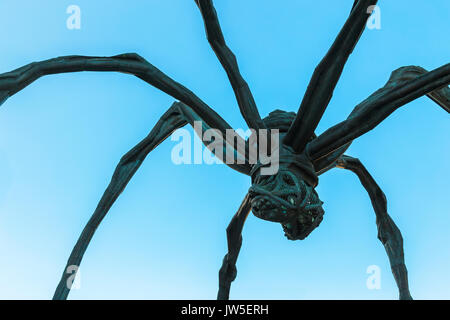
[53,102,250,300]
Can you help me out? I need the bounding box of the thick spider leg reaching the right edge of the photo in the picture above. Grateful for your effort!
[307,63,450,161]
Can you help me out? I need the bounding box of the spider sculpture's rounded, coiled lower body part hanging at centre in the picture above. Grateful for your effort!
[249,168,324,240]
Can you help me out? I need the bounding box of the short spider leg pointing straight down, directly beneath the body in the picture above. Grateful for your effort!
[217,194,251,300]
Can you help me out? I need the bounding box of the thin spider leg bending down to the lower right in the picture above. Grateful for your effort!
[336,155,412,300]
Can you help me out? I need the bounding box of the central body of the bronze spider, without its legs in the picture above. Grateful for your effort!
[249,110,324,240]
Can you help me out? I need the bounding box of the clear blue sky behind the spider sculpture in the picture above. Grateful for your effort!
[0,0,450,299]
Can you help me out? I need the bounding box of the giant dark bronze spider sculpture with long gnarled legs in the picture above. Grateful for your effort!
[0,0,450,299]
